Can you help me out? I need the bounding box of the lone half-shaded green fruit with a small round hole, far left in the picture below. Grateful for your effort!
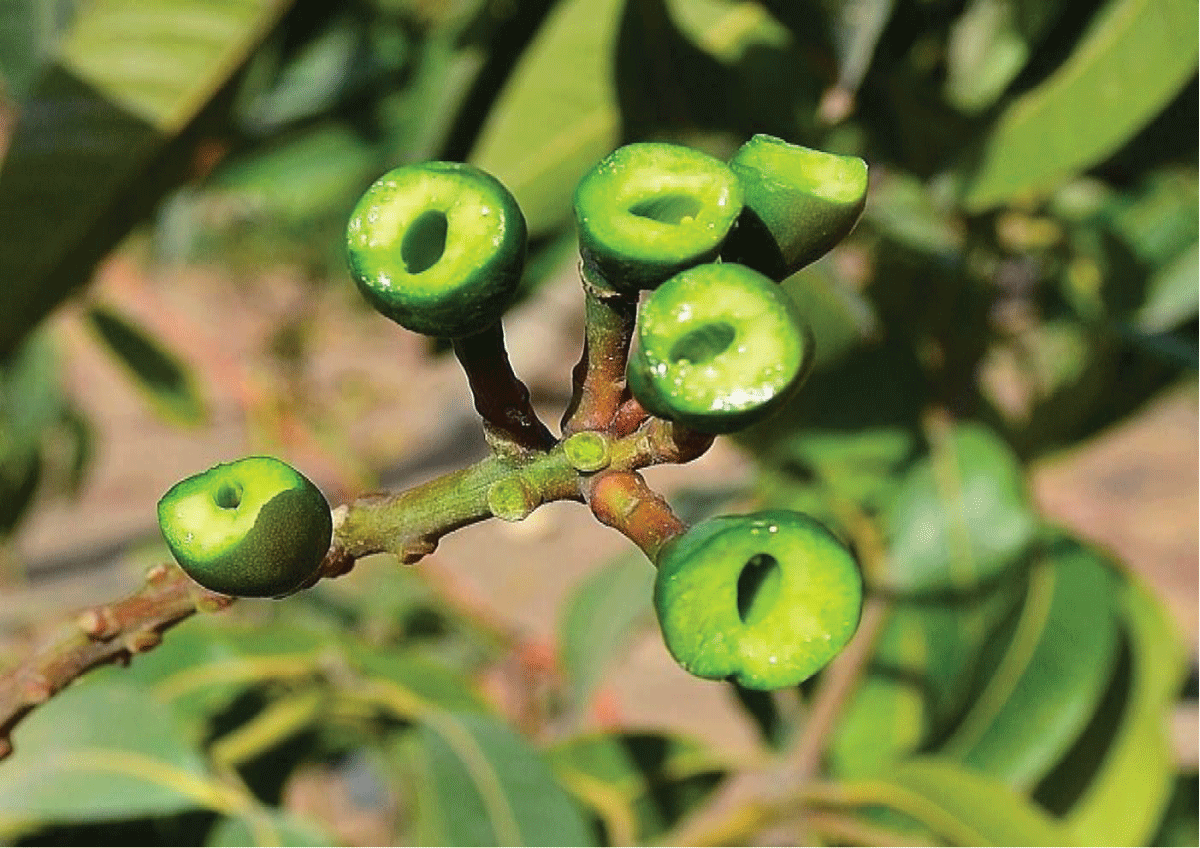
[158,457,334,597]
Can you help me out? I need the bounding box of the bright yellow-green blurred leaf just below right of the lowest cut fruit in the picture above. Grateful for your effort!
[829,613,929,780]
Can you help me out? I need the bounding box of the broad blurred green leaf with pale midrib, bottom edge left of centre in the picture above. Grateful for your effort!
[397,712,594,846]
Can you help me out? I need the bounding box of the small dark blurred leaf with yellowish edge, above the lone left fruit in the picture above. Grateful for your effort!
[88,306,206,425]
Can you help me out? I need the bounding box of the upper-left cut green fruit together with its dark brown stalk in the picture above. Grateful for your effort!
[346,162,554,451]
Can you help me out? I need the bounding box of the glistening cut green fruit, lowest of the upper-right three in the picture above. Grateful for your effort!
[625,263,814,433]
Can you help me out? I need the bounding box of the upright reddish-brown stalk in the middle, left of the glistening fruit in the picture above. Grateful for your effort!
[563,264,637,435]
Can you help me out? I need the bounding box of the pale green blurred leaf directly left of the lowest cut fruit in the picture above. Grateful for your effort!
[558,554,654,710]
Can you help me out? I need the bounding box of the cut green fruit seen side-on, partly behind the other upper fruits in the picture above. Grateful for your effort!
[721,136,866,282]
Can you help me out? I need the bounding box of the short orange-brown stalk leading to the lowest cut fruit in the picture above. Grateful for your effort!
[584,471,688,564]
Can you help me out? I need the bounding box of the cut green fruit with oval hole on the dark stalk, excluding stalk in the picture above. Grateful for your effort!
[346,162,527,338]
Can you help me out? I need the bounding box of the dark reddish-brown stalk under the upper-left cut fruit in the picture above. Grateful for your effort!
[454,321,554,451]
